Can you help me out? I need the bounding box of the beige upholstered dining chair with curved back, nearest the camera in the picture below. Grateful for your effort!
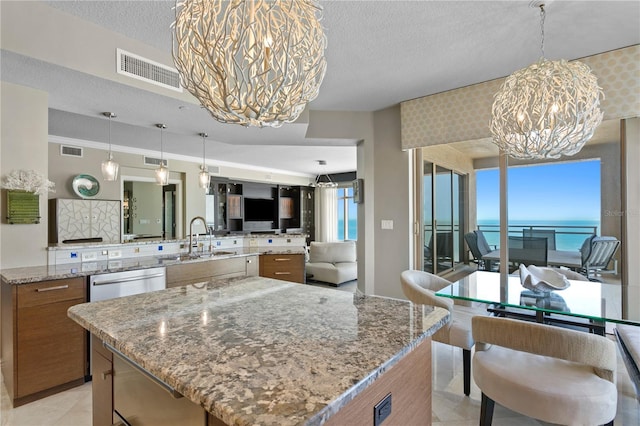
[472,317,618,426]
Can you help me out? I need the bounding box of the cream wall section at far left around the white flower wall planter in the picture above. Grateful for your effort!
[0,82,48,269]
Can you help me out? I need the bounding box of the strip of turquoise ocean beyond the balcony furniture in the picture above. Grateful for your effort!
[478,219,600,250]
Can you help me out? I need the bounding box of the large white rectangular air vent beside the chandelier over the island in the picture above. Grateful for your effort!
[116,49,182,92]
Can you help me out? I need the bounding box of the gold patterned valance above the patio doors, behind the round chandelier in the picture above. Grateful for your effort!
[400,45,640,149]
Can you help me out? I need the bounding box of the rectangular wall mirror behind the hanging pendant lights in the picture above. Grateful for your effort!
[121,176,183,242]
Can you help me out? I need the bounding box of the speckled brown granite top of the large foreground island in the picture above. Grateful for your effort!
[69,277,449,426]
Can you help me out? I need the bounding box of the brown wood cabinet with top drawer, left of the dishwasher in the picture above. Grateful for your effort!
[2,277,88,407]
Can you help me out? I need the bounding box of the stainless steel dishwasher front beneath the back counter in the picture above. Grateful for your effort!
[89,266,167,302]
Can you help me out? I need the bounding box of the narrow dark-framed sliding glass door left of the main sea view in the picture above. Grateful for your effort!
[422,161,465,274]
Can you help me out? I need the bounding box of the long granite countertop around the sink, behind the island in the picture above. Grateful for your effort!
[0,247,304,285]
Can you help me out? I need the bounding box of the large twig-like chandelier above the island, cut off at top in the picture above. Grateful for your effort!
[173,0,327,127]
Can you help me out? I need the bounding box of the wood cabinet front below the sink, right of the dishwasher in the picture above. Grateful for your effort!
[167,255,258,288]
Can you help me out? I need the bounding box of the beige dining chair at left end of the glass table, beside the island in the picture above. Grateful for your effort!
[400,269,487,396]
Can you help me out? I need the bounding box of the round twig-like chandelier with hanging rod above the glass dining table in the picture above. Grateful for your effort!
[491,2,604,159]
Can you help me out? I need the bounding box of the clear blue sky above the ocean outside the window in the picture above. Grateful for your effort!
[476,160,600,223]
